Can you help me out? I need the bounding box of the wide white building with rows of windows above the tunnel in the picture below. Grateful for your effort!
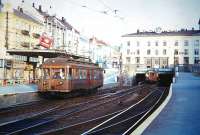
[122,29,200,73]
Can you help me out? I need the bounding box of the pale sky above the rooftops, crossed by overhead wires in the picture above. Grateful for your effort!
[3,0,200,44]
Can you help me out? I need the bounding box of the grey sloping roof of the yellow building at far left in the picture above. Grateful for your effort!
[13,9,42,24]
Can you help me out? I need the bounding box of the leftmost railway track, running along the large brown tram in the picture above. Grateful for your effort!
[0,87,126,125]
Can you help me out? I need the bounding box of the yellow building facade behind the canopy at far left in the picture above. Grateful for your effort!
[0,4,43,83]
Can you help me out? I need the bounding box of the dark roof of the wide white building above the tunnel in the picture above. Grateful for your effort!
[122,30,200,37]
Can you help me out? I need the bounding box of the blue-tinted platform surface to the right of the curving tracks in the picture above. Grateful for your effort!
[142,73,200,135]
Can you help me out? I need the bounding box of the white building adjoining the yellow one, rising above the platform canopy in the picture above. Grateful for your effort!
[32,3,80,54]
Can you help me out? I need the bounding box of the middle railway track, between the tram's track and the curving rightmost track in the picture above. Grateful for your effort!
[0,84,153,134]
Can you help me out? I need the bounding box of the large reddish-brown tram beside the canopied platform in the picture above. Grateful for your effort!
[38,57,103,93]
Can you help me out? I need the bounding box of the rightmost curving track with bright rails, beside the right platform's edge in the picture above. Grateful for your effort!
[82,87,166,135]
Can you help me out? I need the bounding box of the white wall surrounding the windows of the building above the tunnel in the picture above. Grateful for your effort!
[122,36,200,68]
